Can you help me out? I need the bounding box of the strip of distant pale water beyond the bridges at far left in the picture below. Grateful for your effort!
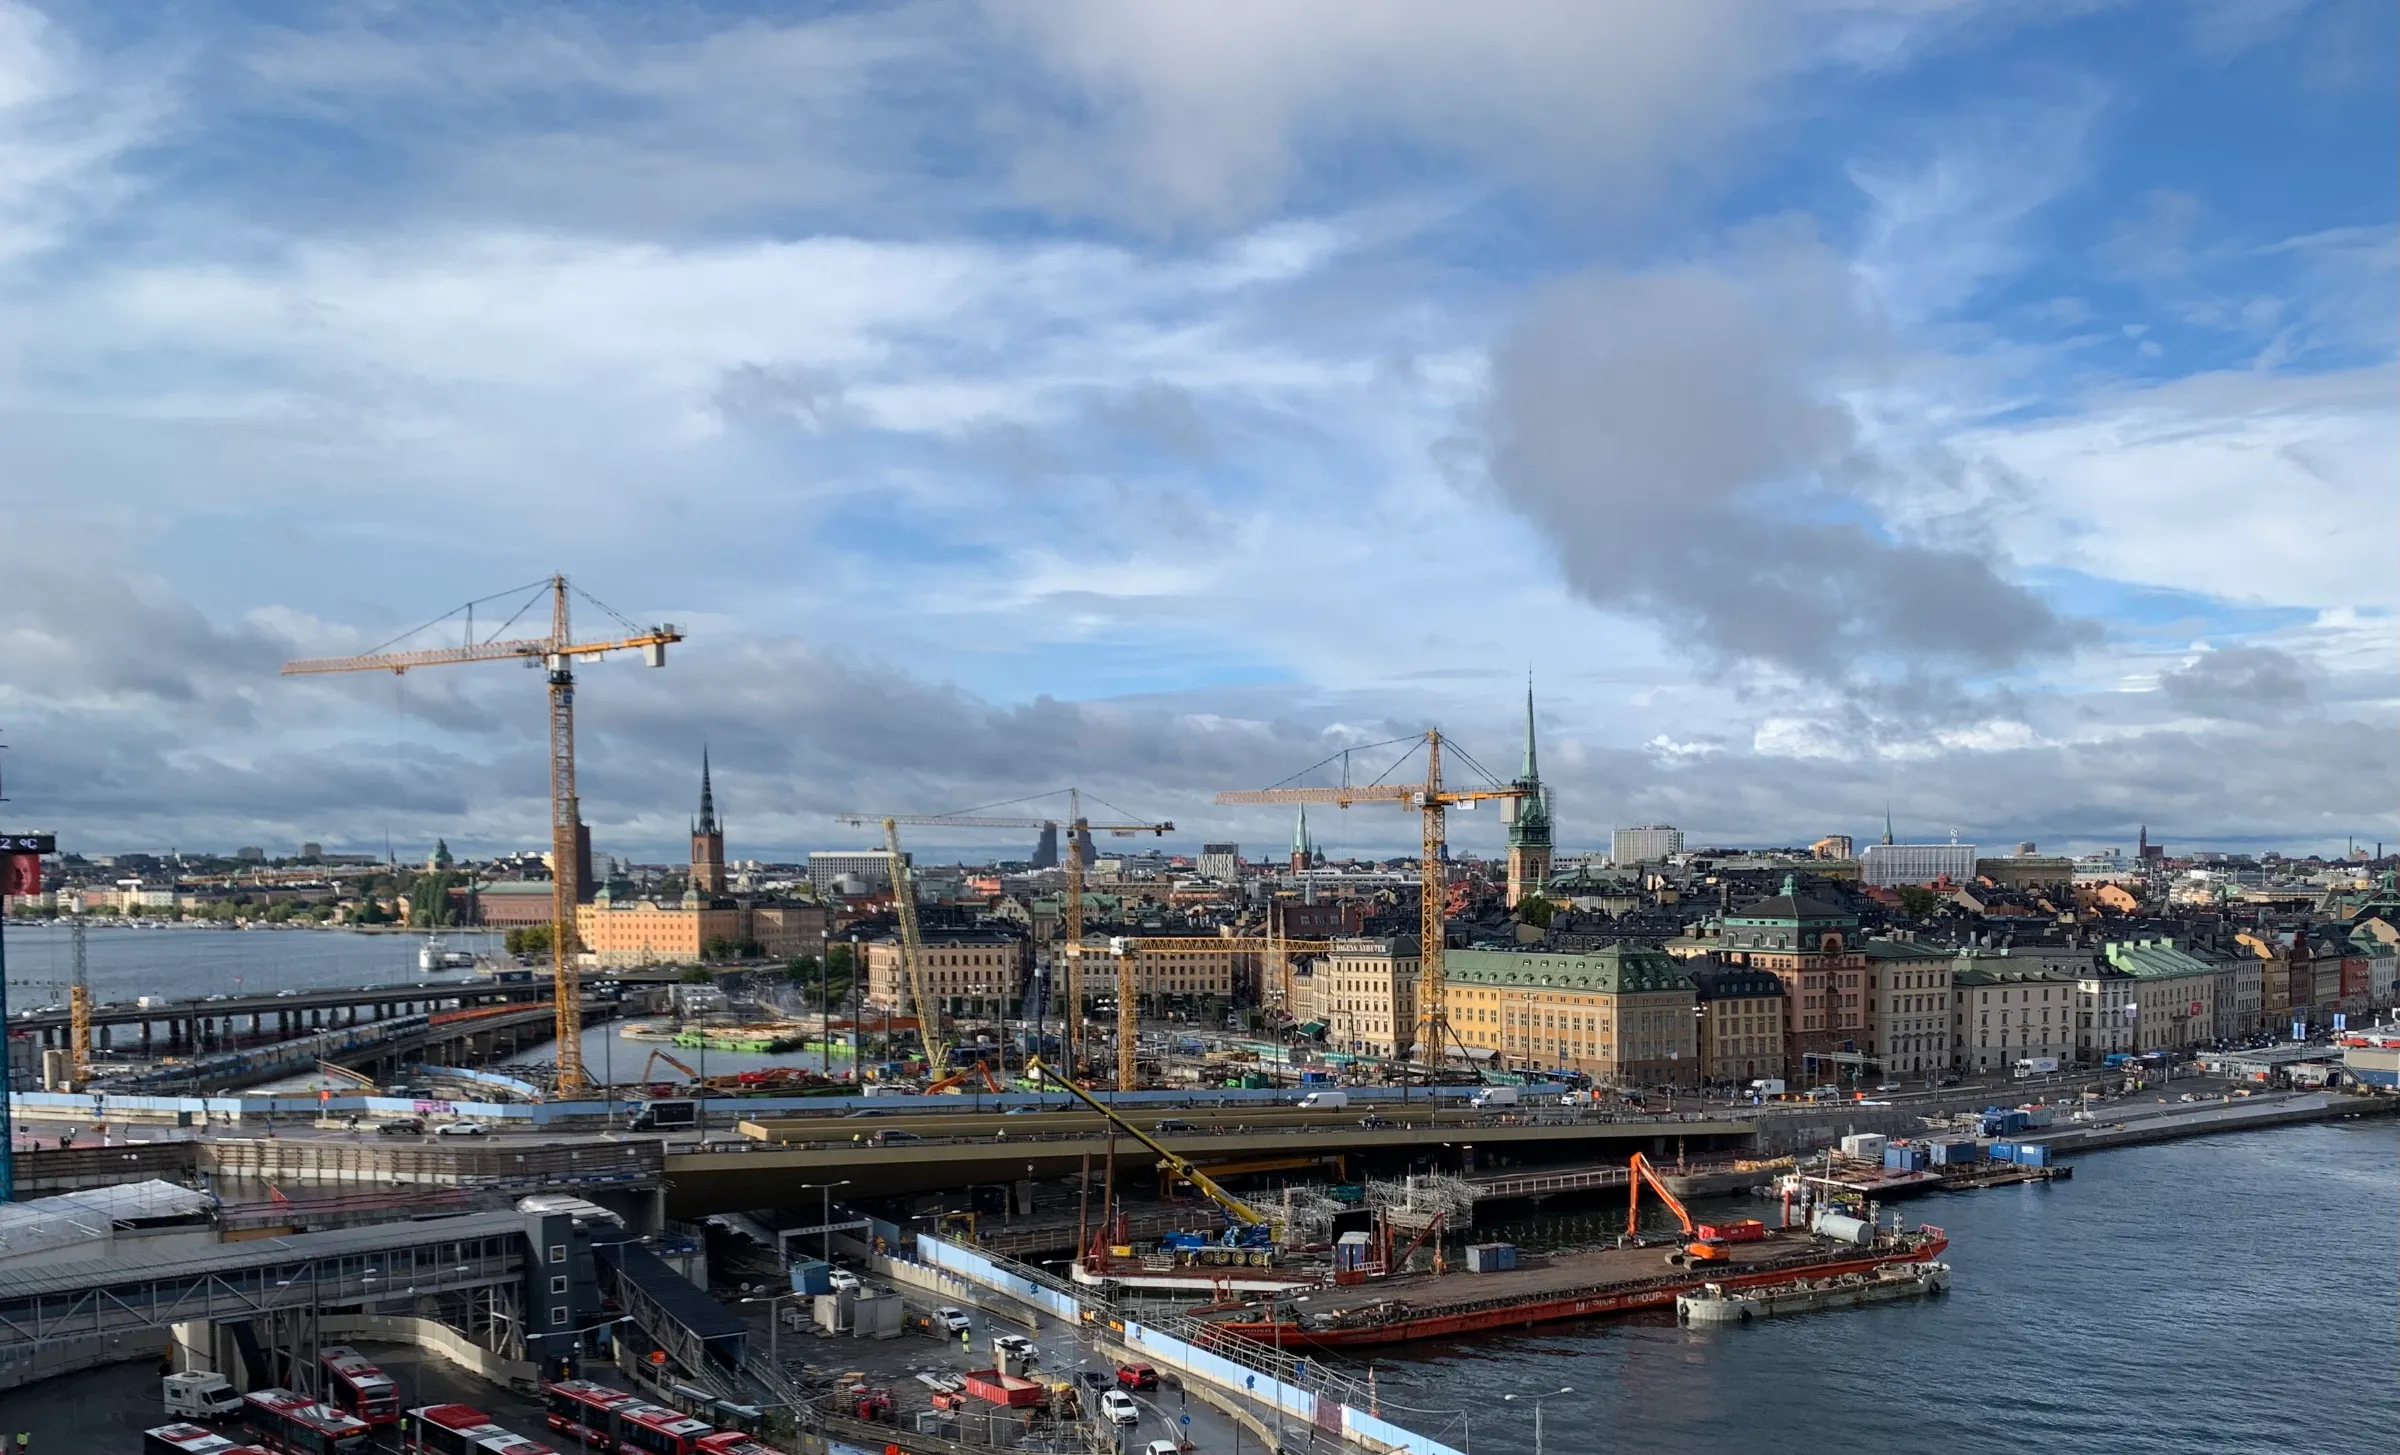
[7,920,502,1011]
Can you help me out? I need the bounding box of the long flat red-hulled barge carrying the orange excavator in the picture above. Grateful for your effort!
[1212,1227,1949,1349]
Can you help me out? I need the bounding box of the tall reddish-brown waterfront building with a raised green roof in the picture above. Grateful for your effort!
[1716,874,1867,1078]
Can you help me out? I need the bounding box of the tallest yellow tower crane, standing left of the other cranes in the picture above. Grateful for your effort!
[283,576,684,1095]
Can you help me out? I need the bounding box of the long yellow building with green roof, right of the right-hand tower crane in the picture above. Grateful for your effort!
[1445,944,1702,1085]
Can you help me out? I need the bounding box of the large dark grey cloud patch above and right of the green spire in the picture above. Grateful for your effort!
[1488,226,2086,682]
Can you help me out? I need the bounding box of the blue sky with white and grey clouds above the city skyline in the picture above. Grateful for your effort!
[0,0,2400,860]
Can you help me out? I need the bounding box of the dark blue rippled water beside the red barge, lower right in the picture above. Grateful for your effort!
[1375,1121,2400,1455]
